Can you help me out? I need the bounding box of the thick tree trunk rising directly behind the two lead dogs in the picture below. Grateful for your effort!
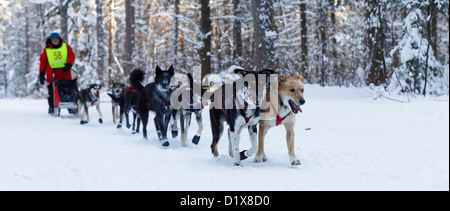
[252,0,277,70]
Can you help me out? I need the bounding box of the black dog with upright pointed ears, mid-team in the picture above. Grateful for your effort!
[137,66,175,147]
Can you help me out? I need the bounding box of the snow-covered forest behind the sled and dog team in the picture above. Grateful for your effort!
[0,0,450,98]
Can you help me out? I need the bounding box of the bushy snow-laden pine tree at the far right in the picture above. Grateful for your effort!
[391,0,448,95]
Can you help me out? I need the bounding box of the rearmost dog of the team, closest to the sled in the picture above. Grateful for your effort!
[77,84,103,125]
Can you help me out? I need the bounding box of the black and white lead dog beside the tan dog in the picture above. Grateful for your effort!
[209,69,274,166]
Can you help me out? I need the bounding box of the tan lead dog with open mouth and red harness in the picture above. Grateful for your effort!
[254,75,306,165]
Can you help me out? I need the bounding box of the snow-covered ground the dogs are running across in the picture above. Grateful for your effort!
[0,85,449,191]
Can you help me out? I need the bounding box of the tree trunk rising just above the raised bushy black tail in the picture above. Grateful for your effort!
[123,0,136,75]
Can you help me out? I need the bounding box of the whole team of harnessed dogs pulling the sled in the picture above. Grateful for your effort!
[78,66,306,166]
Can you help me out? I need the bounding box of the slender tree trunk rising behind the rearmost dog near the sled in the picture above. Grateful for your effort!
[96,0,106,84]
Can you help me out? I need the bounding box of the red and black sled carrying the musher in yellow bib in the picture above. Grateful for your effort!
[52,70,79,116]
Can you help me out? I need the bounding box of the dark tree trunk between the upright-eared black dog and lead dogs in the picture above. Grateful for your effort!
[200,0,212,77]
